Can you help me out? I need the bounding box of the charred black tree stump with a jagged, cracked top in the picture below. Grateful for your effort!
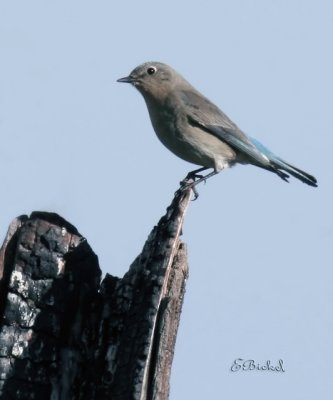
[0,186,191,400]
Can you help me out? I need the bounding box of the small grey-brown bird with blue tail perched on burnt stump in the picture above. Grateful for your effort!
[117,61,318,197]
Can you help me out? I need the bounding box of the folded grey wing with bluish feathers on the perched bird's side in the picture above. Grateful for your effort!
[181,91,270,168]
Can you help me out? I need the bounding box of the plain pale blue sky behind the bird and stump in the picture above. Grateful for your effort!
[0,0,333,400]
